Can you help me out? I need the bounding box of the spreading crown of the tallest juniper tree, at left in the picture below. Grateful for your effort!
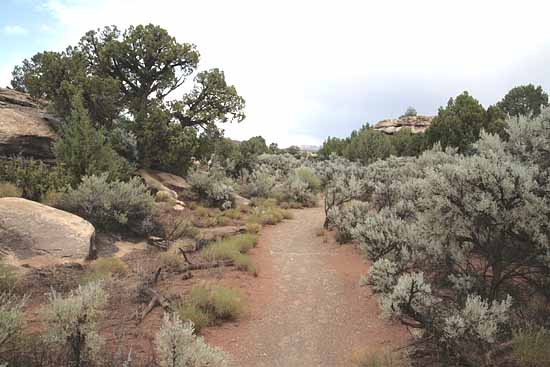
[12,24,244,174]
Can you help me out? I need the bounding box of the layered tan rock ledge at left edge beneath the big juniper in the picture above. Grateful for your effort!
[0,88,59,159]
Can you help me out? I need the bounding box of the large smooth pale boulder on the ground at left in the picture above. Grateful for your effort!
[0,197,96,266]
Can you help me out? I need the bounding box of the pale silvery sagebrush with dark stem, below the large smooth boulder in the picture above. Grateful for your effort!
[44,282,107,367]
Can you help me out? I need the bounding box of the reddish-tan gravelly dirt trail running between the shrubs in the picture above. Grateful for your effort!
[205,208,407,367]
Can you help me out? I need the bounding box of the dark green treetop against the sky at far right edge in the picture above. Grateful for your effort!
[497,84,548,118]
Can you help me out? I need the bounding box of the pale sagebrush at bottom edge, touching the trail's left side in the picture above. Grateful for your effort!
[155,314,228,367]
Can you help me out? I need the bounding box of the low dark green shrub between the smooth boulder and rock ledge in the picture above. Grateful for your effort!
[0,157,70,201]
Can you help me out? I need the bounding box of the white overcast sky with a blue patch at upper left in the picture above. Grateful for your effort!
[0,0,550,146]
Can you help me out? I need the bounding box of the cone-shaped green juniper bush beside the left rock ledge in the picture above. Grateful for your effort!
[54,94,133,183]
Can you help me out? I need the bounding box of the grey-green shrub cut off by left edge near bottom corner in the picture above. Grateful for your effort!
[0,290,25,356]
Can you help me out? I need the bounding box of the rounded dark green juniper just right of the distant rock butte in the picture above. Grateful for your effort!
[425,92,504,152]
